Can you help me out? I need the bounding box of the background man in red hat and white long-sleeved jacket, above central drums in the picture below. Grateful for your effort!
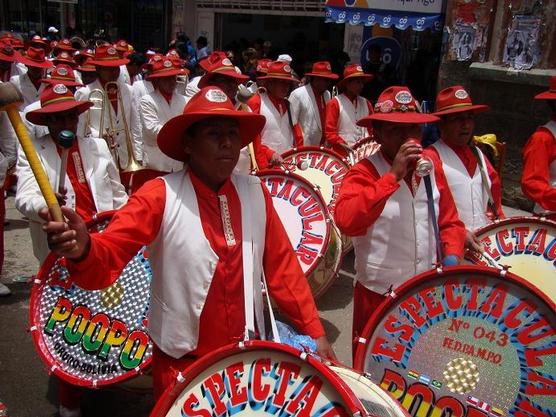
[289,61,339,146]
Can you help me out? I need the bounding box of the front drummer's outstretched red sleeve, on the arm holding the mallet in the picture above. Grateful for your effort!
[68,179,166,290]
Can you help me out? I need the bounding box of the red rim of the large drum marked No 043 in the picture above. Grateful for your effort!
[353,265,556,372]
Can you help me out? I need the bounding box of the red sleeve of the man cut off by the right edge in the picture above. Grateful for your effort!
[521,130,556,211]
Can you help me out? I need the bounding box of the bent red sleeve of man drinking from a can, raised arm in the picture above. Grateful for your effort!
[334,159,400,236]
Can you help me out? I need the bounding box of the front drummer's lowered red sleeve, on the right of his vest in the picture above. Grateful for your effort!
[262,186,325,339]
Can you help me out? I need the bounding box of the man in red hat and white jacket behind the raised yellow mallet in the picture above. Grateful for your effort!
[15,84,127,417]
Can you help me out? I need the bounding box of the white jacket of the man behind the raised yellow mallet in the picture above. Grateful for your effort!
[15,135,127,263]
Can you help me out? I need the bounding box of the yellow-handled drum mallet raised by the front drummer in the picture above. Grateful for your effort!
[0,83,64,222]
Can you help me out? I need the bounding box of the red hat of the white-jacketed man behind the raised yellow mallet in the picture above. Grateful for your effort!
[25,84,93,126]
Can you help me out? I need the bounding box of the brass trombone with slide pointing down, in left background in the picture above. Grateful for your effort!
[85,81,144,172]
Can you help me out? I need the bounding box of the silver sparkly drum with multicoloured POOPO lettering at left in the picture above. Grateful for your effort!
[29,212,152,387]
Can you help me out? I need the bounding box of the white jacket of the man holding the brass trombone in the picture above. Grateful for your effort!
[75,80,143,168]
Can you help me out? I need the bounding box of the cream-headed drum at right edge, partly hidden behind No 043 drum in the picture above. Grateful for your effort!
[466,217,556,302]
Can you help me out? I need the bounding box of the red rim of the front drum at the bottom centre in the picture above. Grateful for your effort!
[150,340,365,417]
